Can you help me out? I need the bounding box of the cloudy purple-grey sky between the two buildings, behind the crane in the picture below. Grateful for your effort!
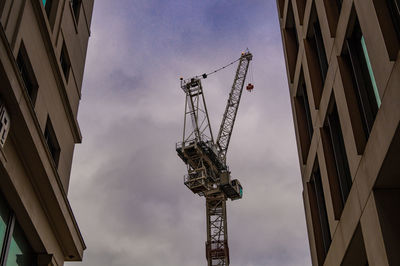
[67,0,311,266]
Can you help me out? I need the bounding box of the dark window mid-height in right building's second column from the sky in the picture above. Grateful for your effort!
[321,104,352,220]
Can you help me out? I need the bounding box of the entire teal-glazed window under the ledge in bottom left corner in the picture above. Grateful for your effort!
[0,194,34,266]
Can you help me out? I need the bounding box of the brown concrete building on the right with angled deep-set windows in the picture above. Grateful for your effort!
[277,0,400,266]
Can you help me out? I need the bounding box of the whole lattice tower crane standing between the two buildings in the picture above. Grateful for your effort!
[176,51,254,266]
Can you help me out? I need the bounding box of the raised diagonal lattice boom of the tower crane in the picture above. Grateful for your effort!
[216,52,253,164]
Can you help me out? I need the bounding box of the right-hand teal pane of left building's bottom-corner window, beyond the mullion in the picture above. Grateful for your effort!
[6,223,33,266]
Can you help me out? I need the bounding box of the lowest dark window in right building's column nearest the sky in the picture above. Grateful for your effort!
[307,164,331,265]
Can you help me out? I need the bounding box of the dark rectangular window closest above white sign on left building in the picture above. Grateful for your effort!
[17,42,38,105]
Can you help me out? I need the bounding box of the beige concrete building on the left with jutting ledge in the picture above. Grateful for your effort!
[0,0,94,266]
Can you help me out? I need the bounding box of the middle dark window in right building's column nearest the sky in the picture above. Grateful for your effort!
[294,71,314,163]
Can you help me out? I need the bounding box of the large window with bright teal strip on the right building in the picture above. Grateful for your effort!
[342,16,381,154]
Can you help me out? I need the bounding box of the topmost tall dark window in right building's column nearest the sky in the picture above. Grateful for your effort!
[283,1,299,82]
